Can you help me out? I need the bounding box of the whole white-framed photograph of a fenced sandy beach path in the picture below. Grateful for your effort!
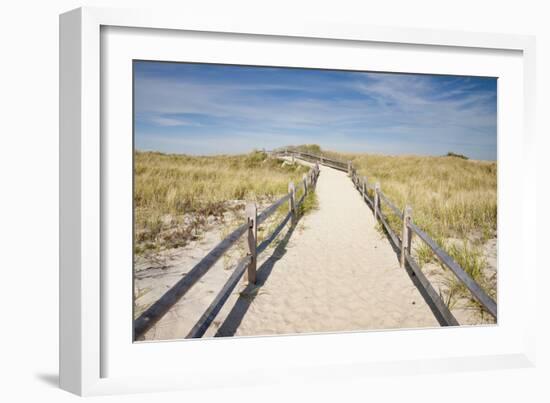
[60,8,536,395]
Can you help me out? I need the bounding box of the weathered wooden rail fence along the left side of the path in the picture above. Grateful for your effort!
[134,164,320,340]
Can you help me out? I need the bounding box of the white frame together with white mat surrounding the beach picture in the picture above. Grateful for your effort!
[60,8,536,395]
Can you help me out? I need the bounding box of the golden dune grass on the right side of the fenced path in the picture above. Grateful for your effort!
[323,152,497,316]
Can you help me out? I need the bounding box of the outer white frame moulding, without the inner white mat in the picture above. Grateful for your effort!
[59,8,536,395]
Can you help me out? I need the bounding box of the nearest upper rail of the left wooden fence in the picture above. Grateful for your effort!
[134,219,248,339]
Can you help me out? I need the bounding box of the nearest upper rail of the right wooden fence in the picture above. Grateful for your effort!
[408,223,497,319]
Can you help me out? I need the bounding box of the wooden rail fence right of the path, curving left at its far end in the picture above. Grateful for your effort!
[275,150,497,326]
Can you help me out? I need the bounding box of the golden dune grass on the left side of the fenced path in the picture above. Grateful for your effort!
[134,151,308,255]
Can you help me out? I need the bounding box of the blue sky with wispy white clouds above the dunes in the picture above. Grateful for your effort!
[134,61,497,160]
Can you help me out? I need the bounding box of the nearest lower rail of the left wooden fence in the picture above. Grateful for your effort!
[185,256,252,339]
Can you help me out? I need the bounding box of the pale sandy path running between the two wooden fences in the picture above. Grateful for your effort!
[216,163,439,336]
